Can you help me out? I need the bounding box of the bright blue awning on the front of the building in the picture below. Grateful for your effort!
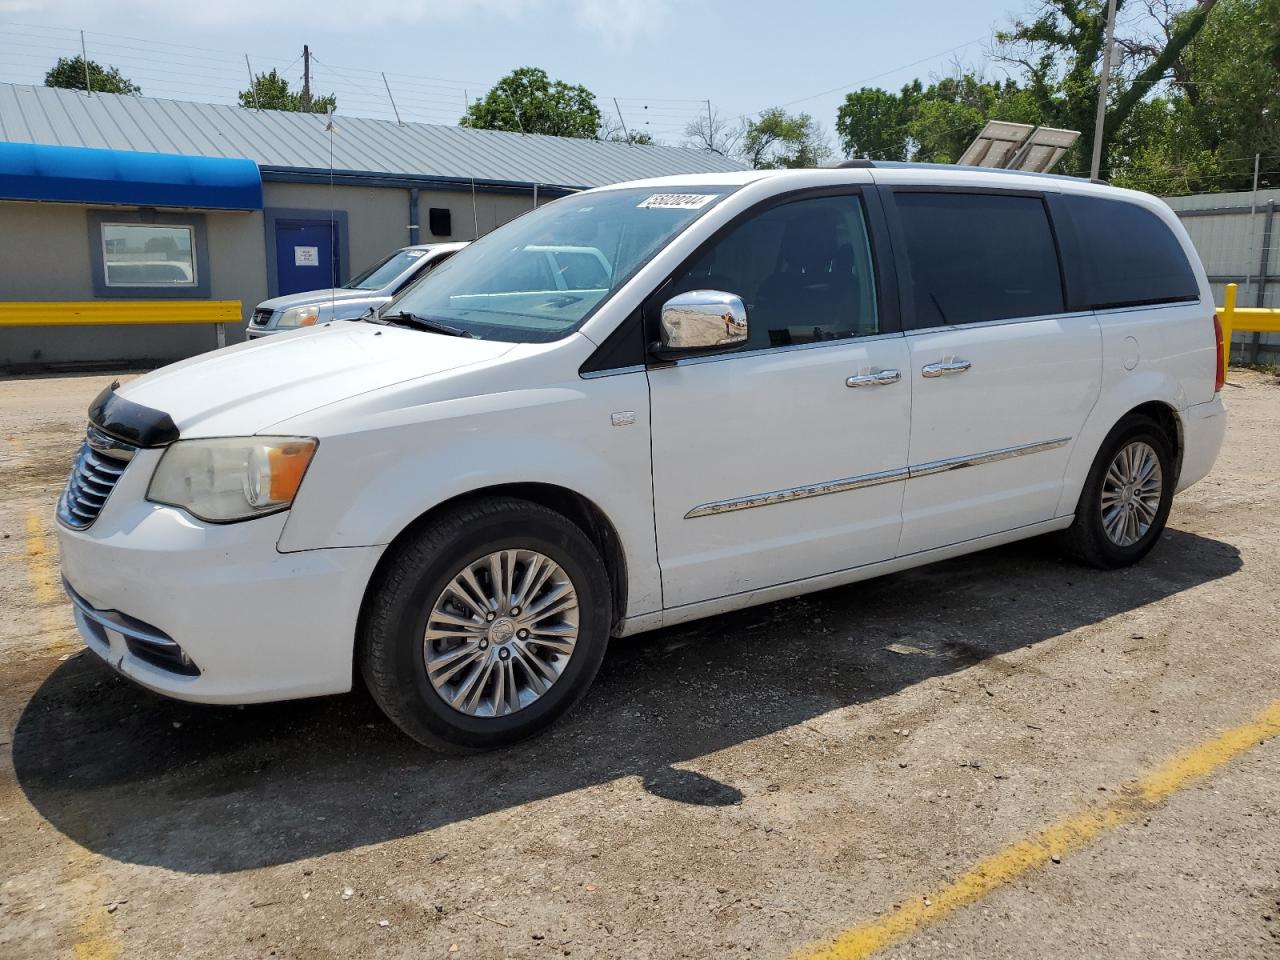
[0,143,262,210]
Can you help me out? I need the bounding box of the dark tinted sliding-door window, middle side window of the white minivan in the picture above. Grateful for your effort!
[895,191,1065,328]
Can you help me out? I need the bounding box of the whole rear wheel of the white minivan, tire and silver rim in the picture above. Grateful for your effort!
[1066,415,1175,570]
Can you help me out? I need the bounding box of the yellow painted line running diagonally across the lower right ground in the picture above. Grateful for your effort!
[792,703,1280,960]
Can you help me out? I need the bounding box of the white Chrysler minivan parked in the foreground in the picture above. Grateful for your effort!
[58,161,1225,750]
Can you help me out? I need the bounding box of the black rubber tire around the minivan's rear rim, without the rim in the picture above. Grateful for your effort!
[1065,413,1178,570]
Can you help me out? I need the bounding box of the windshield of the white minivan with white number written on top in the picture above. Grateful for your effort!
[381,186,736,343]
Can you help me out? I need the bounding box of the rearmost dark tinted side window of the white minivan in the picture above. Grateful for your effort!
[1053,193,1199,310]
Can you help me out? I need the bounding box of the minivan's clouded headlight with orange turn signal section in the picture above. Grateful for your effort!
[147,436,316,524]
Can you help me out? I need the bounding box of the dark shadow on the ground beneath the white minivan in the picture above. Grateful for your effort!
[13,530,1240,873]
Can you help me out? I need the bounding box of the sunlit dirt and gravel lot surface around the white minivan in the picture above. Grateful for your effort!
[0,371,1280,960]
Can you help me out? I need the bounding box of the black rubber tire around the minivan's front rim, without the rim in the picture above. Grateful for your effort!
[358,498,613,753]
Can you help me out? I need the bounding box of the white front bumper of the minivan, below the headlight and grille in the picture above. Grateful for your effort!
[56,451,381,704]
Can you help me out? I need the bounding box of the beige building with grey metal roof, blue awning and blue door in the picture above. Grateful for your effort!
[0,84,740,369]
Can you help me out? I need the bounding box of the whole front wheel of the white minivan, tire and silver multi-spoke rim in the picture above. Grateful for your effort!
[360,498,612,751]
